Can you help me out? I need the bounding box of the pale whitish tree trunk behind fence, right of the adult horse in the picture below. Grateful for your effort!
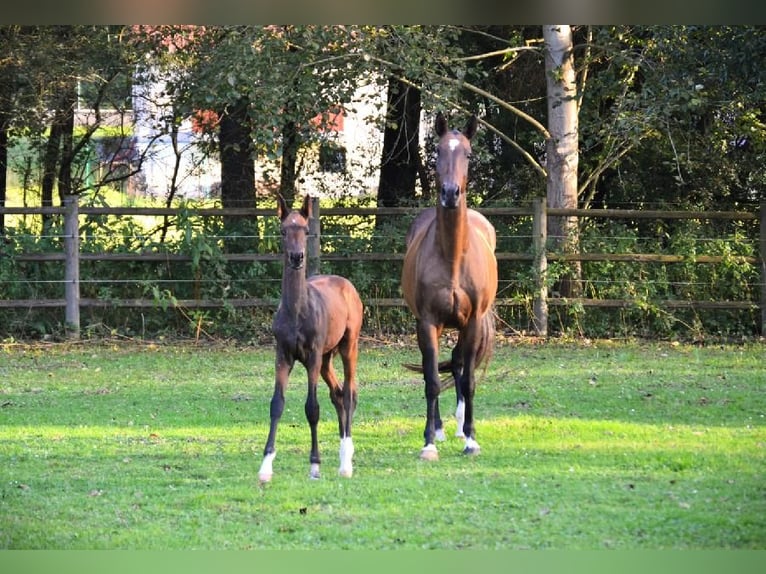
[543,24,581,297]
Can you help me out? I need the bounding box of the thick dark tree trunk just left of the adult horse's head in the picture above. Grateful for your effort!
[377,78,421,230]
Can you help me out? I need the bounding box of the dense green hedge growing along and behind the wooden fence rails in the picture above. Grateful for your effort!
[0,204,760,341]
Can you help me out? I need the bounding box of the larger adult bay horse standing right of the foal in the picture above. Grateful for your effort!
[401,114,497,460]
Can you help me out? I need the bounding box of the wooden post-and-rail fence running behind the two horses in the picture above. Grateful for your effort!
[0,198,766,338]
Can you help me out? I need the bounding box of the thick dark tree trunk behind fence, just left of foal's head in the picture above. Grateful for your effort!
[218,98,258,253]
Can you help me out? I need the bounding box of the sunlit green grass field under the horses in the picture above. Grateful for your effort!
[0,341,766,550]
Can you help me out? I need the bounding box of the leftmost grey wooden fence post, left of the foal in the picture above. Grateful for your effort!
[62,195,80,340]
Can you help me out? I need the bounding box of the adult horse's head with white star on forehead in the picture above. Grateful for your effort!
[436,113,479,209]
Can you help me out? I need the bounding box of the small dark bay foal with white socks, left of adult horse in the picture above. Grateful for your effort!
[258,196,363,482]
